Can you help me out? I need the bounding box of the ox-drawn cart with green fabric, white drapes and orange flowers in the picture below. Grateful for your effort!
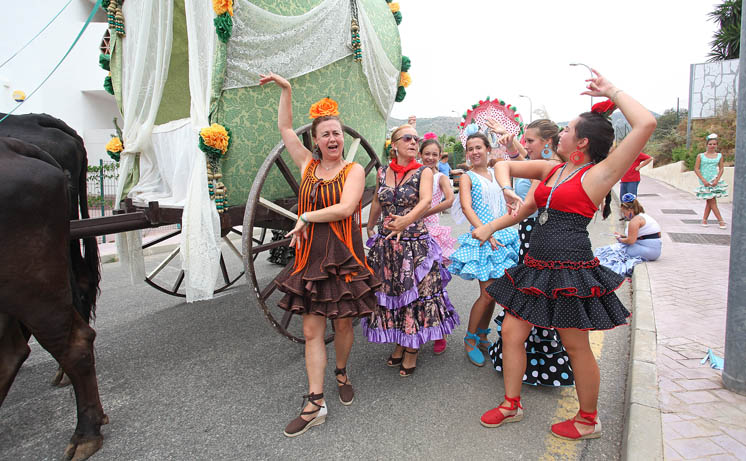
[77,0,409,341]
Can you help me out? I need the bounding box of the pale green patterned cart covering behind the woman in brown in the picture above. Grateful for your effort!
[211,56,386,206]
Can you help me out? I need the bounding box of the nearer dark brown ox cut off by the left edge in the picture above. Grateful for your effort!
[0,137,108,460]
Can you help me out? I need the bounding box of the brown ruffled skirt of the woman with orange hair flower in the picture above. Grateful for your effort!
[275,223,381,319]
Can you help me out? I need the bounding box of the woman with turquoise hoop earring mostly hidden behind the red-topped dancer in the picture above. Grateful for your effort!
[489,119,575,387]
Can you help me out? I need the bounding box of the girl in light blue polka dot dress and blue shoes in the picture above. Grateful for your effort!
[448,132,520,367]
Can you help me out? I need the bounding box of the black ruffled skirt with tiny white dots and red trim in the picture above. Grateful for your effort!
[487,209,630,330]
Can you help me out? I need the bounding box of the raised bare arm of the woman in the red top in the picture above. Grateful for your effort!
[582,69,657,204]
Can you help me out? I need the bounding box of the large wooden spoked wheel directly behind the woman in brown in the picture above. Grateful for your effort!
[243,124,381,343]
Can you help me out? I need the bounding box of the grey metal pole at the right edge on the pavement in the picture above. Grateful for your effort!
[723,0,746,395]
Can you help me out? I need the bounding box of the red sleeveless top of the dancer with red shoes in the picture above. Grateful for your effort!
[534,163,598,218]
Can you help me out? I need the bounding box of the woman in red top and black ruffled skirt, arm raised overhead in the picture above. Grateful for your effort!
[472,70,656,440]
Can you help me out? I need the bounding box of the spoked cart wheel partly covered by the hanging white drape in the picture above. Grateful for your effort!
[142,228,250,298]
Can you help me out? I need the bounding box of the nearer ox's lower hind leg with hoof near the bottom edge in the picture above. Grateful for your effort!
[32,306,109,461]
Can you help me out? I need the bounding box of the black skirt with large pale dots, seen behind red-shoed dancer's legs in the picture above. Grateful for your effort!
[489,311,575,387]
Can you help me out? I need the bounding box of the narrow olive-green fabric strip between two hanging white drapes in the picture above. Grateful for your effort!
[155,0,191,125]
